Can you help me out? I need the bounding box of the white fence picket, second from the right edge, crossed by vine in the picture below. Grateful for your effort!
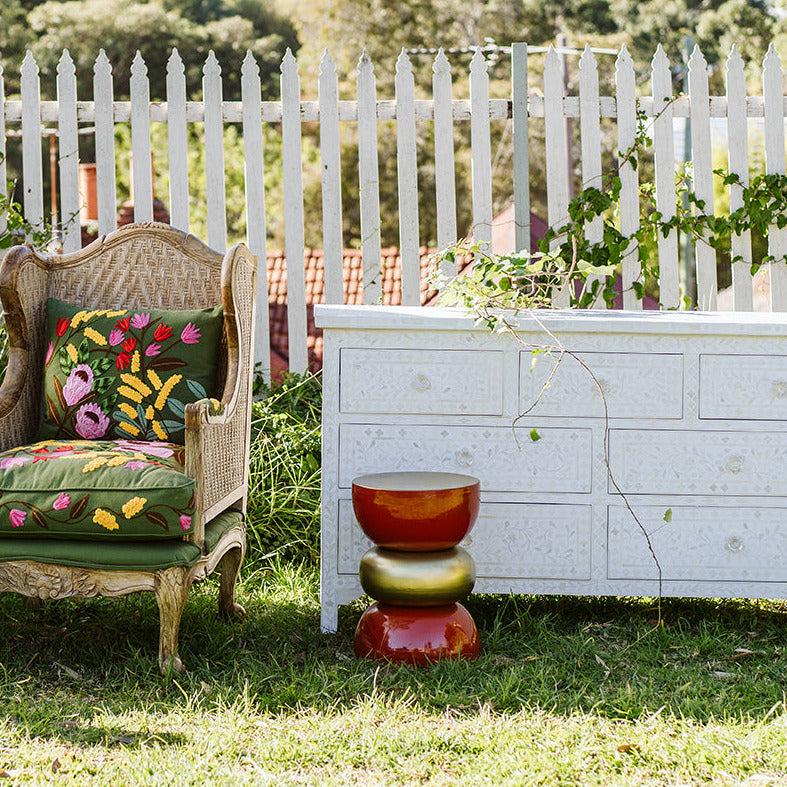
[727,47,754,312]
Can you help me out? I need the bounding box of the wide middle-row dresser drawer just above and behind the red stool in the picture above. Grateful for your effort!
[339,424,592,493]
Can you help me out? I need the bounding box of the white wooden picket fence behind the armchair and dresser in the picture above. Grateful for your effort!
[0,43,787,371]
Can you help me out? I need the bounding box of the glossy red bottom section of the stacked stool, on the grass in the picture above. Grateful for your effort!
[355,602,481,667]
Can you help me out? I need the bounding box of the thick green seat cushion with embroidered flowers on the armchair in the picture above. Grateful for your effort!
[0,440,197,541]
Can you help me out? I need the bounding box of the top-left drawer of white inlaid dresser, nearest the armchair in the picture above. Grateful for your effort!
[339,348,503,415]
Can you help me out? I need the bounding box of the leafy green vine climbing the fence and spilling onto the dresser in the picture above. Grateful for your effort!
[431,98,787,318]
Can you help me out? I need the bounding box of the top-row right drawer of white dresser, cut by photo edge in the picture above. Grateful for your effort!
[699,354,787,420]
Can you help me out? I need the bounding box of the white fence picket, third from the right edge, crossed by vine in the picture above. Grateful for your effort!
[689,45,717,311]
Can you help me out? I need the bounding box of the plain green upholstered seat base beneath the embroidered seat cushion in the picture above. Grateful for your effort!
[0,511,243,571]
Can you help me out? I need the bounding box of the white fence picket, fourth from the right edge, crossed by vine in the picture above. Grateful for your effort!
[653,44,680,309]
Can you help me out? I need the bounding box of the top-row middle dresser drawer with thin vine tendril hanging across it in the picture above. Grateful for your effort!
[519,352,683,418]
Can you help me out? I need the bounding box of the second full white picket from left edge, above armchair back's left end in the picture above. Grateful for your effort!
[57,49,82,252]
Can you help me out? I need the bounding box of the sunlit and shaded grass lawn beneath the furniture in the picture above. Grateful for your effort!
[0,564,787,785]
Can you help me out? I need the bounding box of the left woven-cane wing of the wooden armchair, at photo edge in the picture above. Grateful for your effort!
[0,246,49,451]
